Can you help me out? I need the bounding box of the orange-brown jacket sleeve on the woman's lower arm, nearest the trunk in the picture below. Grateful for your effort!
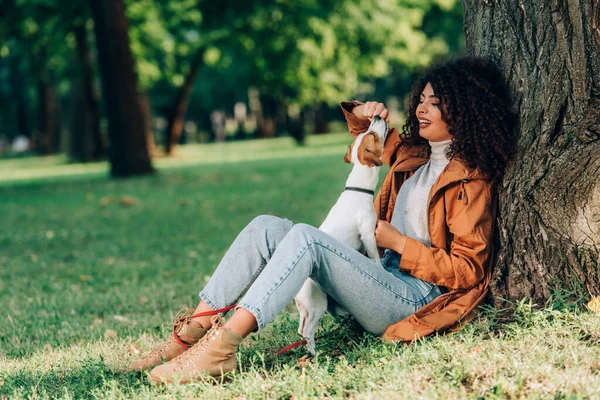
[400,180,493,290]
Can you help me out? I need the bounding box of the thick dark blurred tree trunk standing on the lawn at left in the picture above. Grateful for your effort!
[92,0,154,177]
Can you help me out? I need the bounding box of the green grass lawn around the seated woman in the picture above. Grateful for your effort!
[0,135,600,399]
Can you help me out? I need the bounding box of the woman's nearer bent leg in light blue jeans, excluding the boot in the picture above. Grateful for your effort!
[232,224,441,334]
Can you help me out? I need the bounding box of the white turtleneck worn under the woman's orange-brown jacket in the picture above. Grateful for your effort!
[391,139,452,246]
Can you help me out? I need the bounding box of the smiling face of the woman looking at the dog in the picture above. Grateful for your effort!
[417,83,452,142]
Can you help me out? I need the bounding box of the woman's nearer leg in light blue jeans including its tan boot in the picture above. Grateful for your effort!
[150,224,441,383]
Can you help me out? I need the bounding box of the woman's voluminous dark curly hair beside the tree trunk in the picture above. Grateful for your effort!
[400,57,515,183]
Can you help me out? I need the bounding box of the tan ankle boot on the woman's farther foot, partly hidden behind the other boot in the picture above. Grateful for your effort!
[129,308,207,371]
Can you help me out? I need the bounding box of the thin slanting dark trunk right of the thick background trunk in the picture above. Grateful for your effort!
[165,49,204,154]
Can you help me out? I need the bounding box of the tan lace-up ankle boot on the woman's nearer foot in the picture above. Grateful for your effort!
[150,315,243,383]
